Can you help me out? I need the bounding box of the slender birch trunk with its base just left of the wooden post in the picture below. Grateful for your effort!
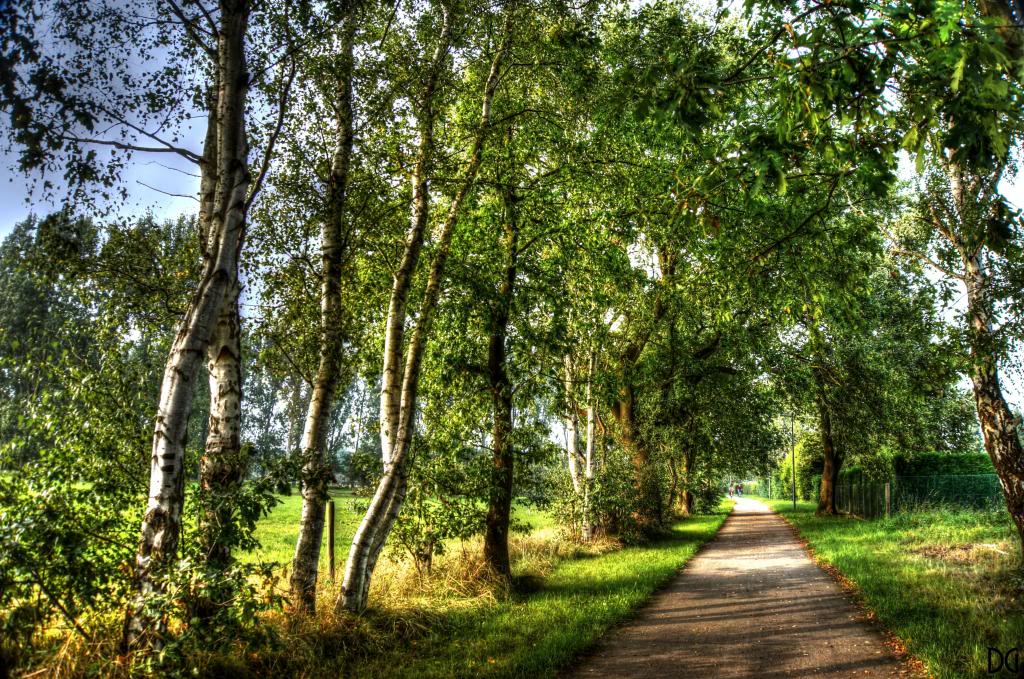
[290,8,355,613]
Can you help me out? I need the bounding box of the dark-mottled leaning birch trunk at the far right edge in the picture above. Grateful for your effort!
[961,250,1024,558]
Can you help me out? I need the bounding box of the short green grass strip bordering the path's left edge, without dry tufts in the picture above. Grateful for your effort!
[345,503,731,677]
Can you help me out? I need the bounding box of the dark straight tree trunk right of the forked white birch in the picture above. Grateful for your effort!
[483,190,519,578]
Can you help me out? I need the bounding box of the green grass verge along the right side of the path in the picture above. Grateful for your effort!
[762,499,1024,678]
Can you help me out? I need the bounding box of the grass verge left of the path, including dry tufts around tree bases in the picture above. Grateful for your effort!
[14,499,724,679]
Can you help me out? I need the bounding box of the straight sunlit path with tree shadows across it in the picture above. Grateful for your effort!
[568,498,913,679]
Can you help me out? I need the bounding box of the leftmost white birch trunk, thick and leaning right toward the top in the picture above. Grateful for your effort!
[122,1,250,650]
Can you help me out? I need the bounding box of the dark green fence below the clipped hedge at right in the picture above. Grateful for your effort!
[836,474,1002,518]
